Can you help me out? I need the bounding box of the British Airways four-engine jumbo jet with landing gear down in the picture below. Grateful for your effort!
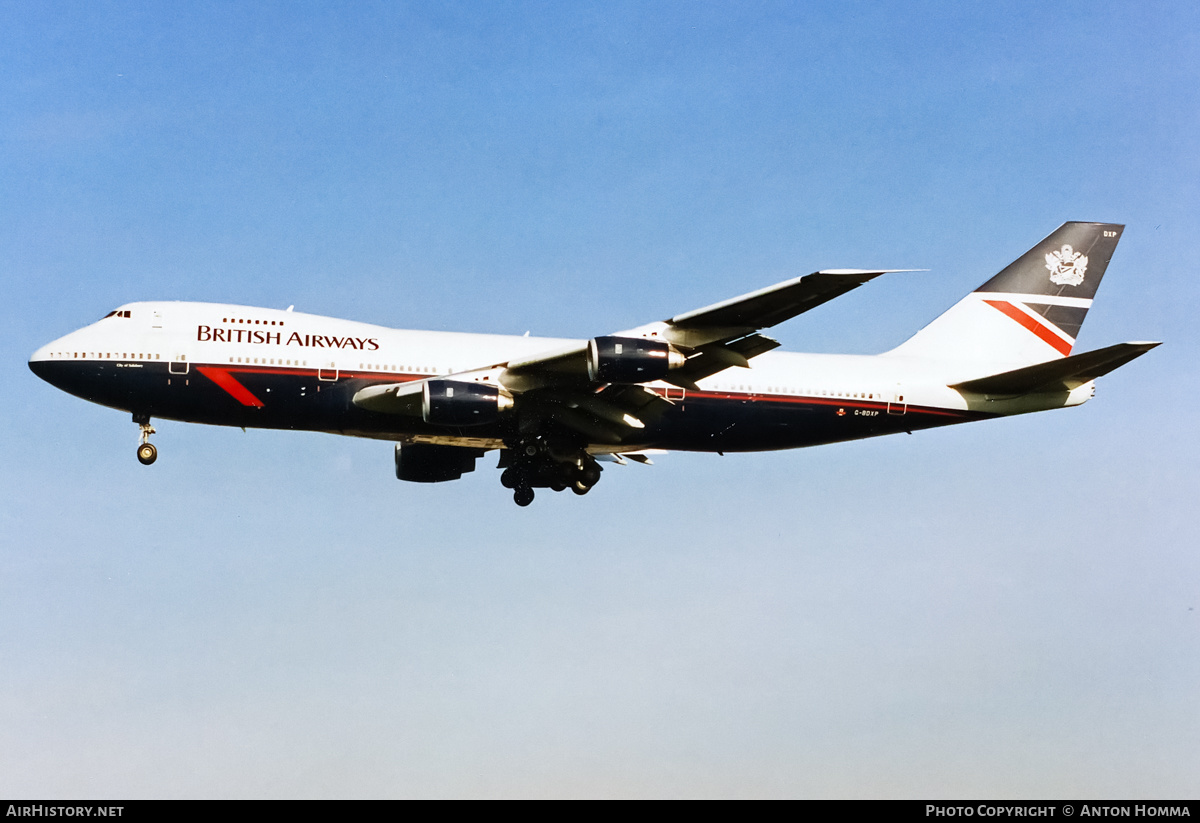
[29,222,1158,506]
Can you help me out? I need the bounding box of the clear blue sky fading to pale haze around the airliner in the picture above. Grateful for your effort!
[0,2,1200,798]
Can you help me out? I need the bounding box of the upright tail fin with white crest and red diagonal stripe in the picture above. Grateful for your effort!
[889,223,1124,366]
